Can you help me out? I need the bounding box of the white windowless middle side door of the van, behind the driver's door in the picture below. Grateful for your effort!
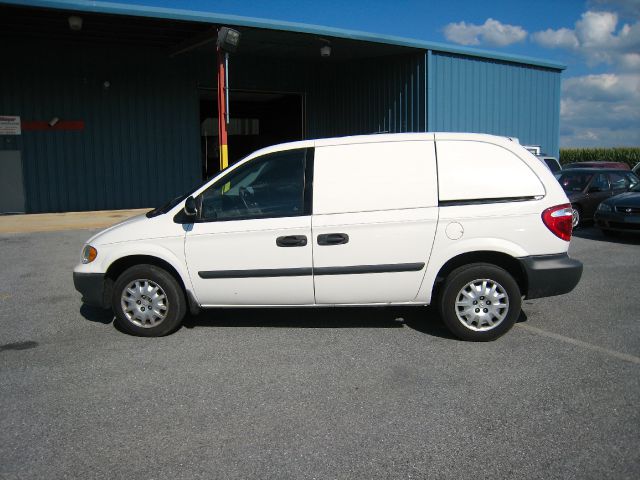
[312,139,438,304]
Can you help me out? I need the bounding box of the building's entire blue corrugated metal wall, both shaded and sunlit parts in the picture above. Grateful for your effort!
[0,41,560,212]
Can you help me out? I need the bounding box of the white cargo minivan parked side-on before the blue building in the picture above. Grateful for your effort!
[74,133,582,340]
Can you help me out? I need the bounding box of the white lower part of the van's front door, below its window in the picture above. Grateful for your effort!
[185,216,314,306]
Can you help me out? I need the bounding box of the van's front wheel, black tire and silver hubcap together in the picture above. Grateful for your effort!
[112,265,187,337]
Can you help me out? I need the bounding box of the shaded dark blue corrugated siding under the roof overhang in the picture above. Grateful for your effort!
[0,46,426,212]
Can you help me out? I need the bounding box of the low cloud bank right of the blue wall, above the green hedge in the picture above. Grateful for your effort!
[560,73,640,147]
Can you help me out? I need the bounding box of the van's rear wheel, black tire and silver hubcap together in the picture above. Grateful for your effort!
[439,263,522,342]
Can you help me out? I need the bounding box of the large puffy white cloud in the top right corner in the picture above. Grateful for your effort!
[531,10,640,71]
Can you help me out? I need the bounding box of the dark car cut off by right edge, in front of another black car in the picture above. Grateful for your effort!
[595,183,640,235]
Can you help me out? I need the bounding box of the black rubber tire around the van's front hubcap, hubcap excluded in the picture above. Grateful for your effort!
[111,265,187,337]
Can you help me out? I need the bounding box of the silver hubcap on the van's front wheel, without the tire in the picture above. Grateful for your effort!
[120,279,169,328]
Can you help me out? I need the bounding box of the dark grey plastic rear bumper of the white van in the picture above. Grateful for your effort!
[518,253,582,298]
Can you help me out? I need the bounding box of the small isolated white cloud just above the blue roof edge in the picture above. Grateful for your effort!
[444,18,527,47]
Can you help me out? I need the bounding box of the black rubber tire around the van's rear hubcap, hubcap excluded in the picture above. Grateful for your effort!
[439,263,522,342]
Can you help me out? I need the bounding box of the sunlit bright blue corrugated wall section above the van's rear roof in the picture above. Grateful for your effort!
[429,52,560,156]
